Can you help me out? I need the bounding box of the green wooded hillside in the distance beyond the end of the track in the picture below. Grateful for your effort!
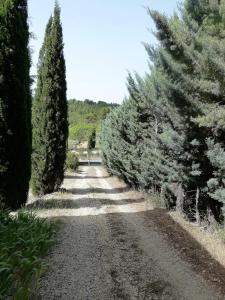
[68,99,118,144]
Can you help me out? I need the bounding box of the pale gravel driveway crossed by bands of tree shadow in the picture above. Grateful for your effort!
[30,167,225,300]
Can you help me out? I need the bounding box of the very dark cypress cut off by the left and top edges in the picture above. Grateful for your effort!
[0,0,31,209]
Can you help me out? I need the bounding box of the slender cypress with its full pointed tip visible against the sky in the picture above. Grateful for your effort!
[32,4,68,195]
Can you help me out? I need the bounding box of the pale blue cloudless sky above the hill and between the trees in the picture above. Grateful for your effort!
[28,0,178,103]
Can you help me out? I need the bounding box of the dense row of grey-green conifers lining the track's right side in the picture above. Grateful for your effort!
[101,0,225,222]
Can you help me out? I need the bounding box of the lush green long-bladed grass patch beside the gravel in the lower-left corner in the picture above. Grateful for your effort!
[0,210,57,300]
